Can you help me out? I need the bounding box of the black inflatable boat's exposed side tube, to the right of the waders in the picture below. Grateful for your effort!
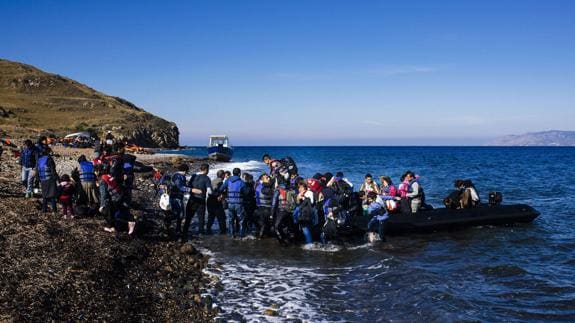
[353,204,540,235]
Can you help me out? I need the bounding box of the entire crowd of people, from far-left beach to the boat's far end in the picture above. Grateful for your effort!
[6,133,480,244]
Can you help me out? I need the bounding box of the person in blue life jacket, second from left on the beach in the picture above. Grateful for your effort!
[36,148,58,214]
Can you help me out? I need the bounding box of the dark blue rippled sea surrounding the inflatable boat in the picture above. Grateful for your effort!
[165,147,575,322]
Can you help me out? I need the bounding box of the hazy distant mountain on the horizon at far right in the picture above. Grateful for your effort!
[488,130,575,146]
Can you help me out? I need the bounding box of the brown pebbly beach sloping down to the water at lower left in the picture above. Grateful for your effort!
[0,147,215,322]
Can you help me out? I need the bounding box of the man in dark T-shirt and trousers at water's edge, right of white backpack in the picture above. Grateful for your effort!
[182,164,212,241]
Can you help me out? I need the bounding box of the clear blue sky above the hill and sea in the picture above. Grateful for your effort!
[0,0,575,145]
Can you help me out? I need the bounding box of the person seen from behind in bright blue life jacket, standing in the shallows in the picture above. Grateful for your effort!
[221,168,245,238]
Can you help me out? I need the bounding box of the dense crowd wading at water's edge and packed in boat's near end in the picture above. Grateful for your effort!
[159,154,476,243]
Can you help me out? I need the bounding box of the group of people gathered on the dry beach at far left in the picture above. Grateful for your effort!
[14,136,154,234]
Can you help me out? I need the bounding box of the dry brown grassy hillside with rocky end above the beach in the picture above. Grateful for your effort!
[0,59,179,148]
